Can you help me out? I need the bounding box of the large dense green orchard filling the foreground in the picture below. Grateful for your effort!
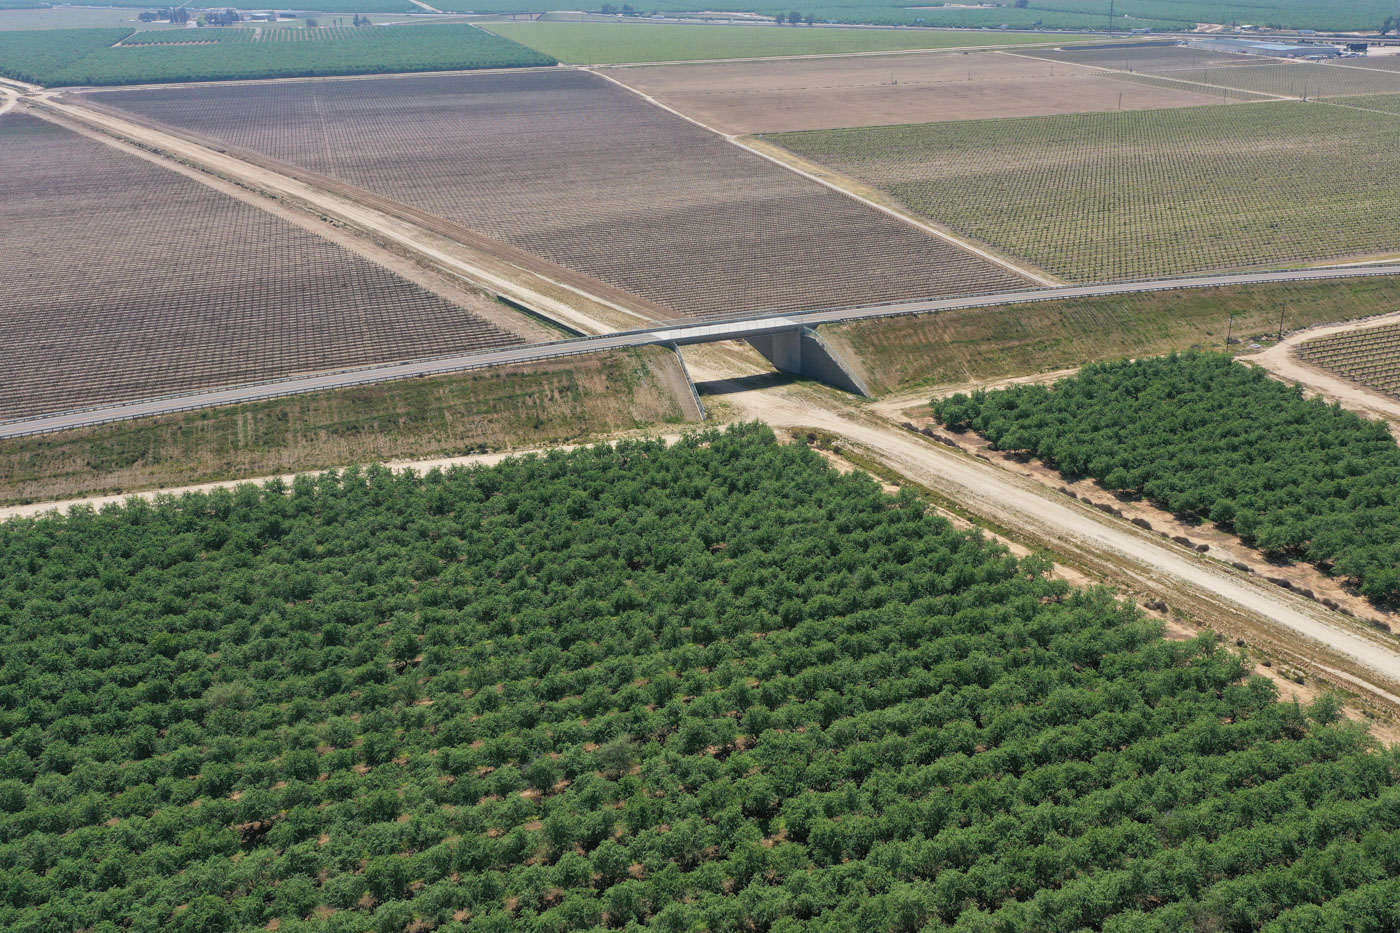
[0,426,1400,933]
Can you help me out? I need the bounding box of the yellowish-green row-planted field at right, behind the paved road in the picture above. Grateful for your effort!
[769,101,1400,282]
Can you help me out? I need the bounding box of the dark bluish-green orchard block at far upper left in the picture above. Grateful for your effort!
[0,24,556,85]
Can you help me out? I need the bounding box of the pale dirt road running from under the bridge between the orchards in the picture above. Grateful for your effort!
[685,347,1400,709]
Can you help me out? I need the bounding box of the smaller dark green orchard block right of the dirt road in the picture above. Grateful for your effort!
[934,353,1400,605]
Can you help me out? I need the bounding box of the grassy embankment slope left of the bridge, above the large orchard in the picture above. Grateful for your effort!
[0,347,693,504]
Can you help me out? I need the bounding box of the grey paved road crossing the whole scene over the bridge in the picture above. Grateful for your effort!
[8,263,1400,438]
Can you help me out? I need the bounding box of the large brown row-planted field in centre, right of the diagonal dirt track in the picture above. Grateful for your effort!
[92,71,1025,315]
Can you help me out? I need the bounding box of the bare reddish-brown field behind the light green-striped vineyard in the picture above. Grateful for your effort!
[608,52,1219,134]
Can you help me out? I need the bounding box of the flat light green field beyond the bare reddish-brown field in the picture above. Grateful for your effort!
[484,22,1054,64]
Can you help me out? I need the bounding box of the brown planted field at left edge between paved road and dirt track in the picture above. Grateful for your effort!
[0,113,522,419]
